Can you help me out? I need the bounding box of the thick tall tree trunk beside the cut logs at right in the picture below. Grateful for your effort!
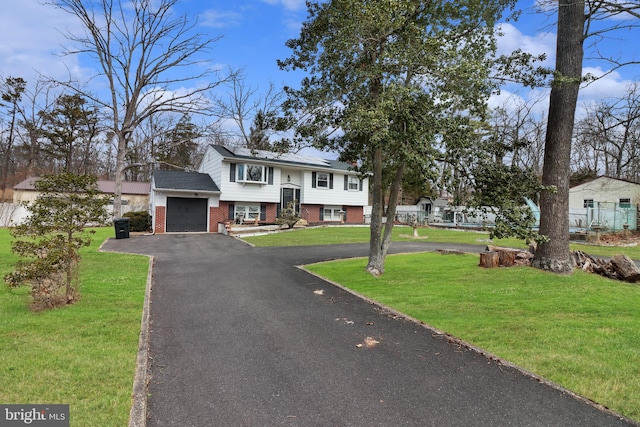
[533,0,585,273]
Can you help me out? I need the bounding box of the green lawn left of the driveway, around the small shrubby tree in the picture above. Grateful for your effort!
[0,228,148,426]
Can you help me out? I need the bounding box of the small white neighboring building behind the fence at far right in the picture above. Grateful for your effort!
[569,176,640,230]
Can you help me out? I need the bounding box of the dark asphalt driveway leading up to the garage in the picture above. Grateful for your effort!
[104,234,633,427]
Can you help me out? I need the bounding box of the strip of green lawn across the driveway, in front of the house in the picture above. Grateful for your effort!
[243,226,640,259]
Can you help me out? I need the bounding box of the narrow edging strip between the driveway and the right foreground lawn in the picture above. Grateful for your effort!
[295,260,640,426]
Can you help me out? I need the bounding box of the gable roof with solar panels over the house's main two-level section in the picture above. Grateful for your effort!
[210,144,353,171]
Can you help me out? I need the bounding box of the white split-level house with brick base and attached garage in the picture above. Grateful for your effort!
[151,145,369,233]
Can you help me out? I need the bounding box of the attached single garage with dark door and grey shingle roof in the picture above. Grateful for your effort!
[151,170,220,233]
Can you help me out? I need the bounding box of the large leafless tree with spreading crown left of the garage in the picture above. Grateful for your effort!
[50,0,234,216]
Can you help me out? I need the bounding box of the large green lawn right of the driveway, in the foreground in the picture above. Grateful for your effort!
[307,252,640,420]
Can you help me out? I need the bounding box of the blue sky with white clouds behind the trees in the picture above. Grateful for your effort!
[0,0,640,141]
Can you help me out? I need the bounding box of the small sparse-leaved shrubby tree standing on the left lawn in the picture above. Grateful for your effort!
[4,172,107,309]
